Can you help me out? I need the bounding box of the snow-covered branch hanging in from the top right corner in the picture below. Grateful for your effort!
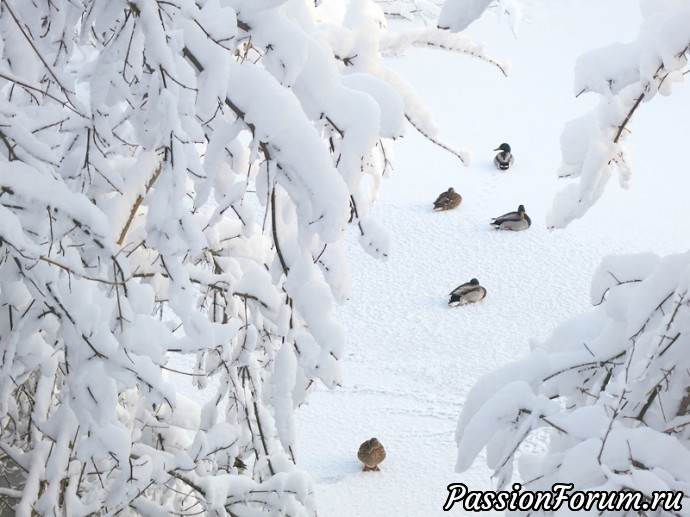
[547,1,690,228]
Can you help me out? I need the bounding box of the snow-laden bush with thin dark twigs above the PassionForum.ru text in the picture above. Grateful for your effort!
[457,253,690,515]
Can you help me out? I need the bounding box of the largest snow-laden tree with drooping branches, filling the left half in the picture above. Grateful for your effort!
[0,0,506,516]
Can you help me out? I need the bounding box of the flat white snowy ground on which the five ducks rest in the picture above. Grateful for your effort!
[297,0,690,517]
